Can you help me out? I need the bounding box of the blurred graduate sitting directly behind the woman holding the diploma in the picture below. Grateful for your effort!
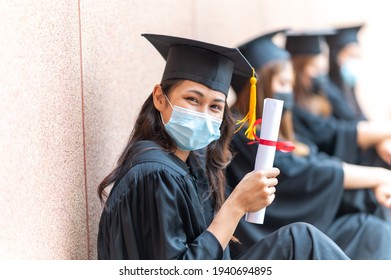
[226,31,391,259]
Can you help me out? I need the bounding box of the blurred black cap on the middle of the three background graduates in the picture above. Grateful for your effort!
[285,29,335,55]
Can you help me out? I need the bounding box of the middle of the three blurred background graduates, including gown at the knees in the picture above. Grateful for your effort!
[285,31,391,220]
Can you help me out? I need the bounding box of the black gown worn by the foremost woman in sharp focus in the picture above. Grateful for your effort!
[98,141,347,260]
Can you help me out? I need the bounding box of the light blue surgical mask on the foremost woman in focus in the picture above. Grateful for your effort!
[162,96,222,151]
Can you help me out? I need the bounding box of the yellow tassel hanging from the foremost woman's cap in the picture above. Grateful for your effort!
[235,68,257,140]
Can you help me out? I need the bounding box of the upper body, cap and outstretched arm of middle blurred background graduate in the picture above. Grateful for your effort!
[285,32,391,168]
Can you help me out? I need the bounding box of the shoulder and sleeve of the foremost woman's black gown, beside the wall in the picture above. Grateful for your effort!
[98,143,223,259]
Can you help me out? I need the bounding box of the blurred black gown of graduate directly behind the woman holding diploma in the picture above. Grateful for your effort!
[226,128,391,259]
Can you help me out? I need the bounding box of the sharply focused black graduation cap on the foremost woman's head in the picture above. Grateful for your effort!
[141,34,255,95]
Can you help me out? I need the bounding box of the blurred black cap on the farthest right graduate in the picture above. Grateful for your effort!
[326,24,364,54]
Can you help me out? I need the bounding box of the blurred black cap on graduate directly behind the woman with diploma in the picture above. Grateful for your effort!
[232,29,290,94]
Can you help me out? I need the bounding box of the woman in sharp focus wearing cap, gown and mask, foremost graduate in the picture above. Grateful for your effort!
[98,34,347,260]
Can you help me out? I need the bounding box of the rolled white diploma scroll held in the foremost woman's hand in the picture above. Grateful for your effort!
[245,98,284,224]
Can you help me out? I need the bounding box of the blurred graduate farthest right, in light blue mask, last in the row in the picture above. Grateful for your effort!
[326,24,391,166]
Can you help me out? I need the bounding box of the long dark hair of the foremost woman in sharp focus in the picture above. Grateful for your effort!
[97,79,235,211]
